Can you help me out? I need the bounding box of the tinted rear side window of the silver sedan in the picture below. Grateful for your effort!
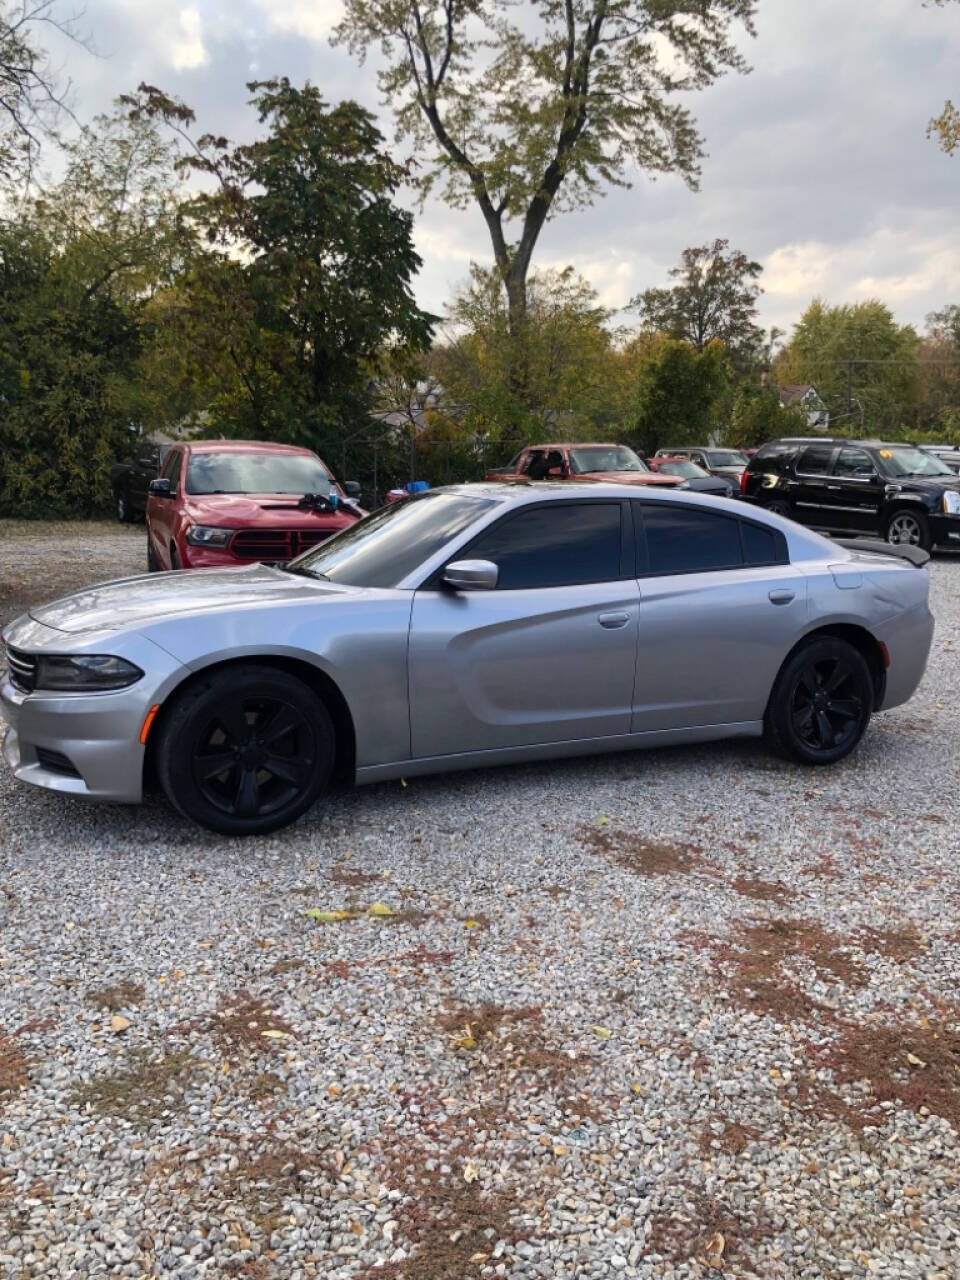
[634,503,790,573]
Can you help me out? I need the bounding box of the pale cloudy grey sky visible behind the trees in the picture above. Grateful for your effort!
[47,0,960,329]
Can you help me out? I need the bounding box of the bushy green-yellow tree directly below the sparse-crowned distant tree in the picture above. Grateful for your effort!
[623,333,730,457]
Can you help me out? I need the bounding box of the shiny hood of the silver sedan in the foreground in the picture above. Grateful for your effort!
[29,564,357,634]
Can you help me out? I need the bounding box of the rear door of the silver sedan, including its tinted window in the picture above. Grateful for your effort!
[631,500,806,733]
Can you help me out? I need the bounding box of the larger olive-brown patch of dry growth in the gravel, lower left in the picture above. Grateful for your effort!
[70,1050,202,1123]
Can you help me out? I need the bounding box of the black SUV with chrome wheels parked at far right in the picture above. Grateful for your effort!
[740,438,960,550]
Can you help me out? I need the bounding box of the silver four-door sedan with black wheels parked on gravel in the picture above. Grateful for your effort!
[0,483,933,835]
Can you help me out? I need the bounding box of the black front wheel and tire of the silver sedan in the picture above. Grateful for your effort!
[156,663,335,836]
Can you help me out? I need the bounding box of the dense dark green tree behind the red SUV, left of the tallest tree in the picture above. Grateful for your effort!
[125,79,433,447]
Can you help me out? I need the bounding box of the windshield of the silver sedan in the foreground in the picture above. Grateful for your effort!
[287,490,494,588]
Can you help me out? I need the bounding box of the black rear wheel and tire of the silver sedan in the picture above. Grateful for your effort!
[764,636,874,764]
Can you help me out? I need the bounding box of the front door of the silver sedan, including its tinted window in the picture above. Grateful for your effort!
[410,499,639,759]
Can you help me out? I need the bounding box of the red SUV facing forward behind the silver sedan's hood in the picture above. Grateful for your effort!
[147,440,365,570]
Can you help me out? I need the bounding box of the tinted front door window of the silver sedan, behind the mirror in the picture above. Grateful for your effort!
[461,502,621,590]
